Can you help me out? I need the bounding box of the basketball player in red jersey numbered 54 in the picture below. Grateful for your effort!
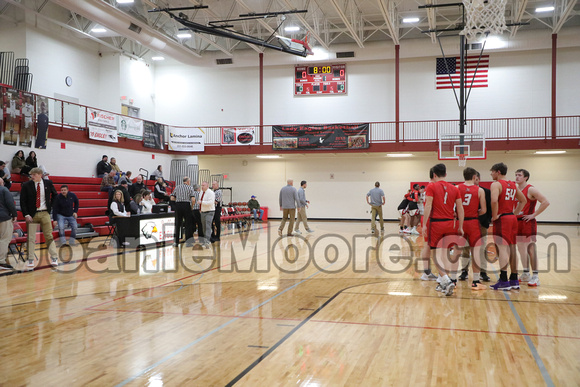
[490,163,527,290]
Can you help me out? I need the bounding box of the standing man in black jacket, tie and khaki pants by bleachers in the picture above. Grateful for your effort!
[20,168,58,267]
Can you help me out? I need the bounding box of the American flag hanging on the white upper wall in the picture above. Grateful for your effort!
[435,55,489,90]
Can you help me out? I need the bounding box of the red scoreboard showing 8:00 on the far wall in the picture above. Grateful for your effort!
[294,64,346,95]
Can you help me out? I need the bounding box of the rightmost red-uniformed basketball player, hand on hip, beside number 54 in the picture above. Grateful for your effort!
[516,169,550,286]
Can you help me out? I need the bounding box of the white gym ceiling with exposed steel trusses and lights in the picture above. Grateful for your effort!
[0,0,580,59]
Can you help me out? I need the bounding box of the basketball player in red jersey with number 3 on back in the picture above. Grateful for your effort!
[453,167,487,290]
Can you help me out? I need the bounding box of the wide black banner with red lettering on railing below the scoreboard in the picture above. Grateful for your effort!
[272,124,369,150]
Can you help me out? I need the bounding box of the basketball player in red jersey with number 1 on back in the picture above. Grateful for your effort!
[423,164,463,296]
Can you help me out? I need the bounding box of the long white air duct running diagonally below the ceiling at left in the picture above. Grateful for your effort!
[52,0,201,64]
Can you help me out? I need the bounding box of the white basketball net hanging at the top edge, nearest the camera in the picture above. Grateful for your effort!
[460,0,507,40]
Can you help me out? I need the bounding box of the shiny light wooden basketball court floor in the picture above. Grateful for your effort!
[0,221,580,386]
